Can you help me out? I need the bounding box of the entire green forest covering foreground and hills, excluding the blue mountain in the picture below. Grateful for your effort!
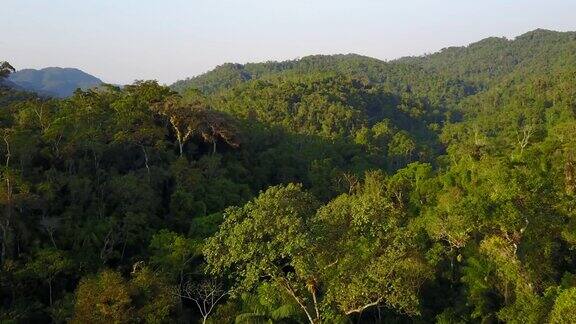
[0,30,576,323]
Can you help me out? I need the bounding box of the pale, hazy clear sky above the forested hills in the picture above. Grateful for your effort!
[0,0,576,84]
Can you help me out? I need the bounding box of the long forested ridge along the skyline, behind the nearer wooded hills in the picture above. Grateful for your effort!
[171,29,576,93]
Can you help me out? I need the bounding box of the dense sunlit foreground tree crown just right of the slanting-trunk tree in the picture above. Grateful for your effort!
[312,172,432,315]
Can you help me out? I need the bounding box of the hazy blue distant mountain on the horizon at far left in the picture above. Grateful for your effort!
[8,67,102,98]
